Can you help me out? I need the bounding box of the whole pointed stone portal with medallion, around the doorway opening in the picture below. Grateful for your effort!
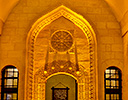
[25,6,98,100]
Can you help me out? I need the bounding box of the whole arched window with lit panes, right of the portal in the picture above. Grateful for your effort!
[104,67,122,100]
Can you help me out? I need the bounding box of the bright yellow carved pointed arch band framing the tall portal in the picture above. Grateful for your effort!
[25,5,98,100]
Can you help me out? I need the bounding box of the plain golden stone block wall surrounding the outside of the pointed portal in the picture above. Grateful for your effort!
[0,0,124,100]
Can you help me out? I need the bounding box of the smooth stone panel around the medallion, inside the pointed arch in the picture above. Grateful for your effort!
[34,17,90,73]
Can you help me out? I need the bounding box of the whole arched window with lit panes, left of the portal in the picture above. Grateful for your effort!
[1,66,18,100]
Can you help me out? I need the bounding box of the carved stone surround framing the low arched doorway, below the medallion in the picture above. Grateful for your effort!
[34,61,89,100]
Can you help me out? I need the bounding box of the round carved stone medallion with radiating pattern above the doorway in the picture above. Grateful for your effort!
[51,31,73,52]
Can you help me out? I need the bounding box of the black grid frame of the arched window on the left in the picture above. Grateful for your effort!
[1,65,19,100]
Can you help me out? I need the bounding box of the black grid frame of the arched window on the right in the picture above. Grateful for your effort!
[104,66,122,100]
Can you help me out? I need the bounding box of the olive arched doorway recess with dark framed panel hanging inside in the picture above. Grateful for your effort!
[45,74,77,100]
